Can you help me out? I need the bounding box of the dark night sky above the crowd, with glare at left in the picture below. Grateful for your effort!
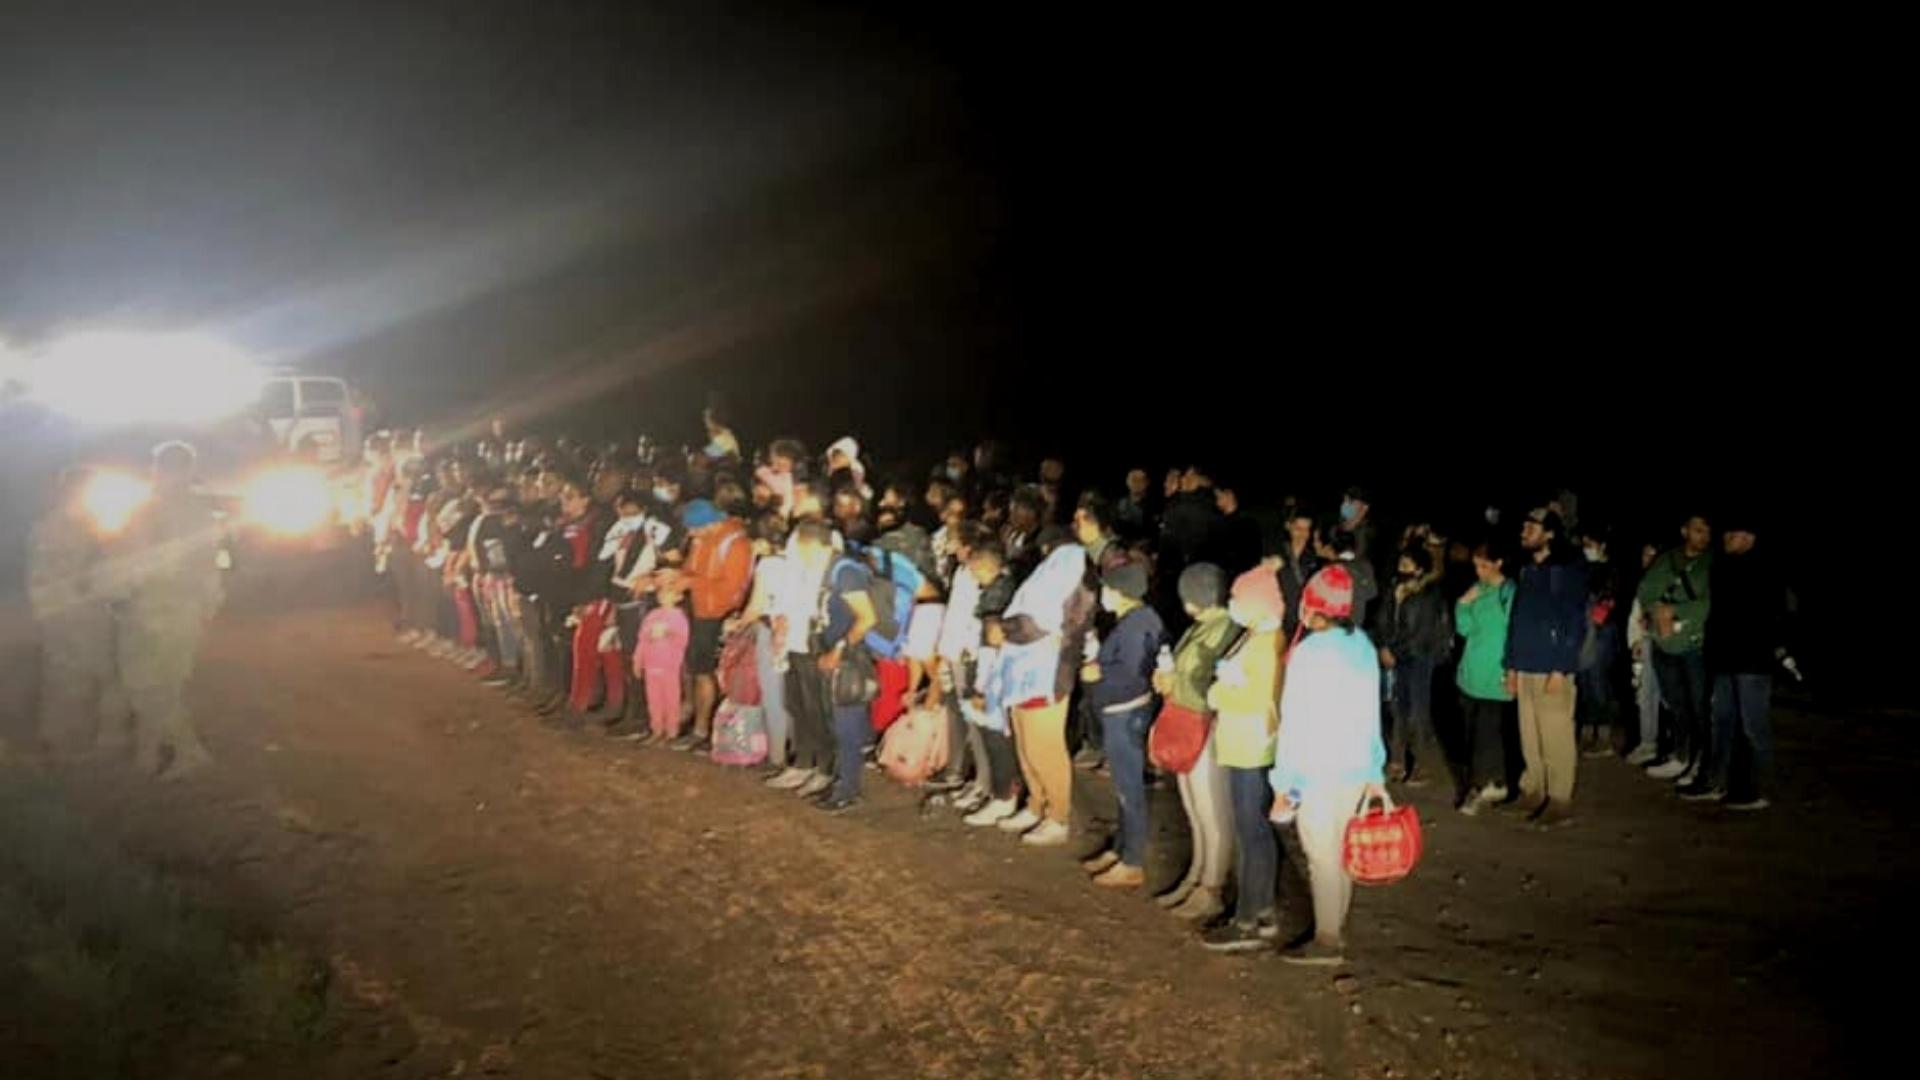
[0,2,1910,699]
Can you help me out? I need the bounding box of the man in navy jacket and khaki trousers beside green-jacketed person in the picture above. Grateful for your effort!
[1505,507,1586,824]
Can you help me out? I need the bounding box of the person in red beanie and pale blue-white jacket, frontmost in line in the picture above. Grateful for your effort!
[1267,567,1386,965]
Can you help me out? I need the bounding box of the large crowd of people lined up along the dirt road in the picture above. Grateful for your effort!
[365,409,1793,965]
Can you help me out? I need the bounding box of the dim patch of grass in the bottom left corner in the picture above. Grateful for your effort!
[0,765,334,1078]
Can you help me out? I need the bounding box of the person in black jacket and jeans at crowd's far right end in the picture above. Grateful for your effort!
[1704,517,1793,811]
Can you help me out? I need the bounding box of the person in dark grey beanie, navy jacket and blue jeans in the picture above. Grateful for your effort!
[1081,563,1165,888]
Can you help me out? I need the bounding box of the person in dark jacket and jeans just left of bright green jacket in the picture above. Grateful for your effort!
[1375,548,1453,782]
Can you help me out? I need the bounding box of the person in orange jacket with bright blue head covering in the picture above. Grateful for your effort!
[674,500,753,751]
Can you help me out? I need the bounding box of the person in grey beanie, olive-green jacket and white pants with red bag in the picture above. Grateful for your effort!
[1154,563,1242,922]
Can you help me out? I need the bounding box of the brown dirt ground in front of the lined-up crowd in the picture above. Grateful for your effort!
[7,591,1920,1080]
